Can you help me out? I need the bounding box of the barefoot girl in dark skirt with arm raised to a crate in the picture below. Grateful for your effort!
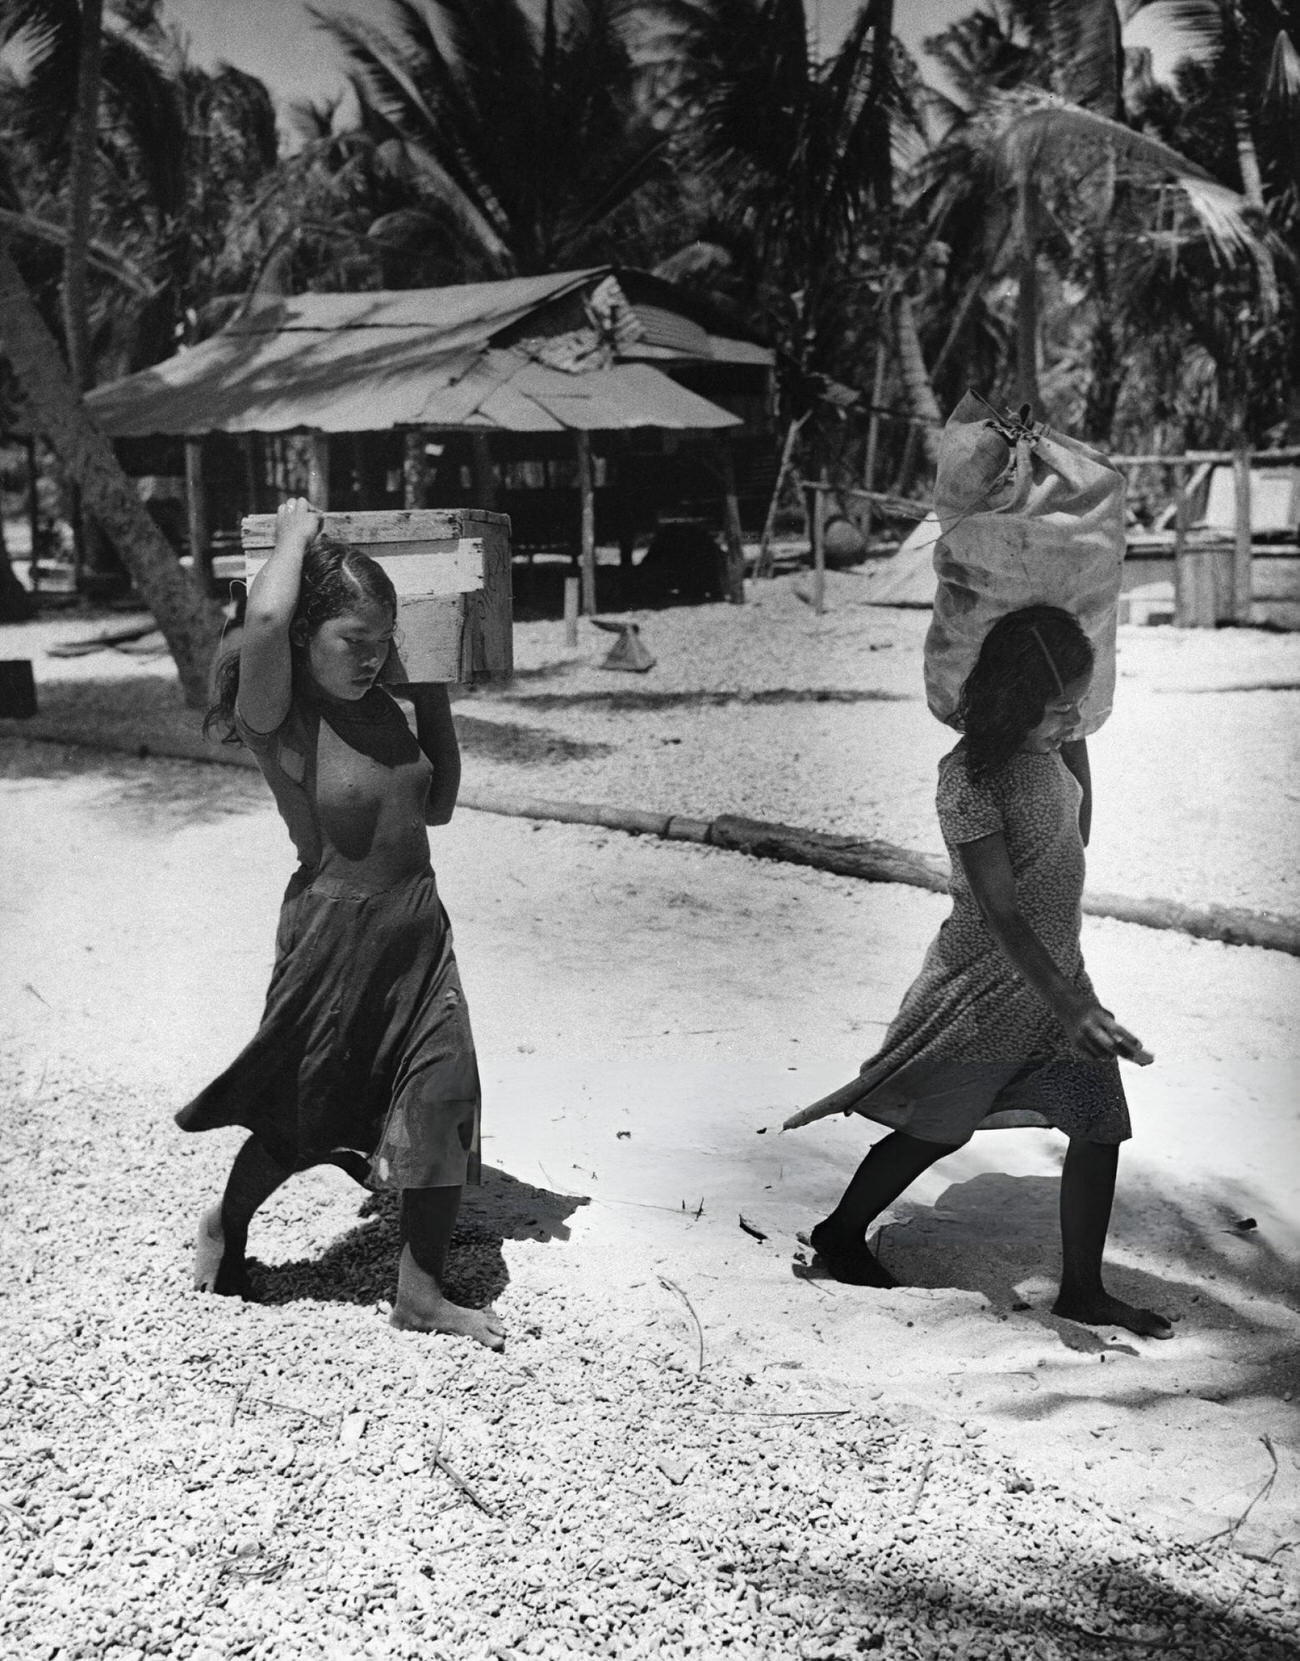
[176,498,505,1349]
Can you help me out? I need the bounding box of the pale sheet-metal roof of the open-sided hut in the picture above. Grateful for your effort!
[86,267,757,439]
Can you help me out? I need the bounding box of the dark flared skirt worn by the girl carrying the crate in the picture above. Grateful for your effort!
[176,870,480,1189]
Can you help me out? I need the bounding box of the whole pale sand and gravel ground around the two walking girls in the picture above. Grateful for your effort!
[0,573,1300,1661]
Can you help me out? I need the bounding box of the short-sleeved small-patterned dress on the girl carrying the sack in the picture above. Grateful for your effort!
[853,744,1131,1146]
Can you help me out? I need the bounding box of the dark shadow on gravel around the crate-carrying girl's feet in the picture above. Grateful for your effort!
[249,1166,588,1309]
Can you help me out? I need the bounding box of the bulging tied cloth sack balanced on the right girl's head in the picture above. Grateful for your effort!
[925,392,1124,737]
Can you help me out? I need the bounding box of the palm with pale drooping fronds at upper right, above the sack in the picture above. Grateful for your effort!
[916,0,1272,440]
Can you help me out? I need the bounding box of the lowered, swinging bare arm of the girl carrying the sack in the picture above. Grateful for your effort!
[956,831,1144,1060]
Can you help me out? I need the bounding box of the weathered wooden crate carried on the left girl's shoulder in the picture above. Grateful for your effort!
[241,508,513,681]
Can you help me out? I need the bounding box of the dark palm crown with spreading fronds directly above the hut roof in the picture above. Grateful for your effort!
[312,0,664,277]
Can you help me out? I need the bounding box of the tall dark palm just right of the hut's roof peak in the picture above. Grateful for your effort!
[628,0,910,531]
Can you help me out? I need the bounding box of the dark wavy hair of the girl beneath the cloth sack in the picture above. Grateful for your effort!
[956,606,1092,777]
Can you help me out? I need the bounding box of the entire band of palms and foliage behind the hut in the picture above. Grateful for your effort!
[0,0,1300,677]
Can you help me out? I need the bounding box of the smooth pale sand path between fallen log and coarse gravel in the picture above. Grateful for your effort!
[0,756,1300,1531]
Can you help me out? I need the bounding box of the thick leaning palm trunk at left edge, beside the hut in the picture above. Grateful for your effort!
[0,241,222,709]
